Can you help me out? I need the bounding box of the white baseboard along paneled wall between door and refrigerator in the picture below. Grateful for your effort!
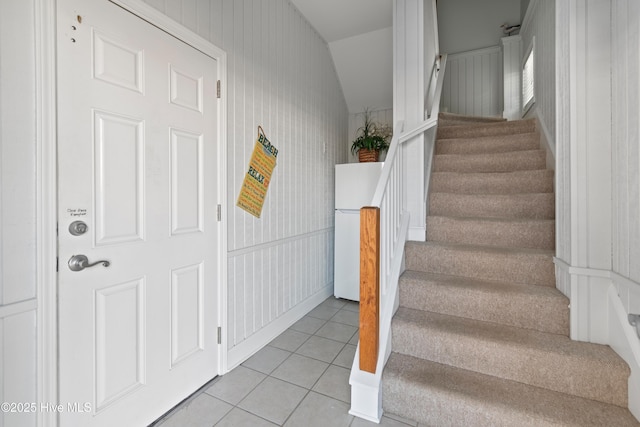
[224,284,333,373]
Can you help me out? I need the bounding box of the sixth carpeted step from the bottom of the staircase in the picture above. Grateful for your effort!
[429,191,555,219]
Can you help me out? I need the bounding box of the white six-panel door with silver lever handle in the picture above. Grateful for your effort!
[57,0,219,426]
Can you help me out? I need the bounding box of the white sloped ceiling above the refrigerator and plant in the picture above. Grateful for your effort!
[291,0,393,113]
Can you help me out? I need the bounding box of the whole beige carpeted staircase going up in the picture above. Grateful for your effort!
[382,115,639,427]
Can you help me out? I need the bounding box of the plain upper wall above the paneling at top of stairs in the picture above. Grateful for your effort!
[438,0,521,54]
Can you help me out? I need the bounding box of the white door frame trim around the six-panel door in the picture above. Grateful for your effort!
[35,0,227,427]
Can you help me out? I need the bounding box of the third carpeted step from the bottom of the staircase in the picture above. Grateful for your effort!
[399,270,569,336]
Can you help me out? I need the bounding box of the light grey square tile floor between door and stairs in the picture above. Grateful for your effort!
[154,297,417,427]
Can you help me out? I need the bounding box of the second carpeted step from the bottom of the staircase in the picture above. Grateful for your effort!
[392,307,630,407]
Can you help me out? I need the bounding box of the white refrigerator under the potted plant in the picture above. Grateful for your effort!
[333,162,384,301]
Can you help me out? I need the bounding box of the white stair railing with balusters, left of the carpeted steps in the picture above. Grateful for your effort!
[349,44,446,422]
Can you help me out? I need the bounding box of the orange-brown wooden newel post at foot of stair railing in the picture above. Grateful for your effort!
[360,206,380,373]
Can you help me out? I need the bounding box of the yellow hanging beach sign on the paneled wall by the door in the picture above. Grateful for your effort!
[236,126,278,218]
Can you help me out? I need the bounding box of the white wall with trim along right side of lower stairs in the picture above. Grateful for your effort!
[552,0,640,418]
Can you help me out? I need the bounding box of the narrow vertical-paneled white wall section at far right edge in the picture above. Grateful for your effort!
[611,0,640,313]
